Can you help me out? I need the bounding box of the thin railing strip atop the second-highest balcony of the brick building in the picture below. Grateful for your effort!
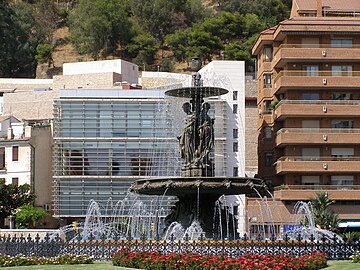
[274,70,360,83]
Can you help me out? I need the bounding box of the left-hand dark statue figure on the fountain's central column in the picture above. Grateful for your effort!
[178,102,196,166]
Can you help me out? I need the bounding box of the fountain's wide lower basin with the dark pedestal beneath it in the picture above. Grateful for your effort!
[130,177,266,238]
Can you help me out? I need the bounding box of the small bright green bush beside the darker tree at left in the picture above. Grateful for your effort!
[15,204,47,229]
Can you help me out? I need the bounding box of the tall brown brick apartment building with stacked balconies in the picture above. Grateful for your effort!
[253,0,360,229]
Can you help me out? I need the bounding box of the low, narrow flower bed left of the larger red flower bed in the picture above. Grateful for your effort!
[0,254,94,267]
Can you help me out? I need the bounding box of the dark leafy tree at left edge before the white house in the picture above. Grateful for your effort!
[0,179,35,228]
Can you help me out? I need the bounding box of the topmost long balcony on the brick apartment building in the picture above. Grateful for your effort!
[273,44,360,68]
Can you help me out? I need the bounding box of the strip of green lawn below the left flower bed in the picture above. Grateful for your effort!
[0,261,139,270]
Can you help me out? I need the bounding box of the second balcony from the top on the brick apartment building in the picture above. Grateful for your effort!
[273,70,360,95]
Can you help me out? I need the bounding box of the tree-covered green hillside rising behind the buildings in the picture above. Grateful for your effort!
[0,0,291,77]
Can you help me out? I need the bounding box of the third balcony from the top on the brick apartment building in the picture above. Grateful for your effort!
[275,100,360,120]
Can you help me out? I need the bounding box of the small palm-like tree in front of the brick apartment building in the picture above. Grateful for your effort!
[310,192,340,231]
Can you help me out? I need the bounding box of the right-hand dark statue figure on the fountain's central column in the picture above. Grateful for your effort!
[196,102,214,162]
